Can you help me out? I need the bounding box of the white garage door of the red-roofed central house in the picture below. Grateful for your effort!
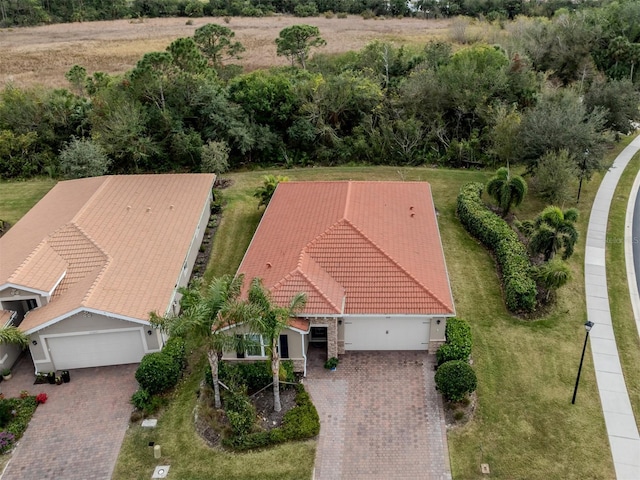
[344,317,430,350]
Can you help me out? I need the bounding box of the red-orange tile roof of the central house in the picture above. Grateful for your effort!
[238,182,454,315]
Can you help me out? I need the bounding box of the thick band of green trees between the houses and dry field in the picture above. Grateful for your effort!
[0,3,640,182]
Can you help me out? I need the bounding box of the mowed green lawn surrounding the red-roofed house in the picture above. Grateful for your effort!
[0,141,630,480]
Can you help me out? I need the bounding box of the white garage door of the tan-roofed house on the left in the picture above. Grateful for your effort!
[46,330,144,370]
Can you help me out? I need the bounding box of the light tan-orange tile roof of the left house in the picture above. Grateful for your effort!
[0,174,215,331]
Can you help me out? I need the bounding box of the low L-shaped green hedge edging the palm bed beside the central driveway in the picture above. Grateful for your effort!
[222,384,320,450]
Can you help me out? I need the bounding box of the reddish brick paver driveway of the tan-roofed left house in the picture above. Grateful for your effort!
[0,356,137,480]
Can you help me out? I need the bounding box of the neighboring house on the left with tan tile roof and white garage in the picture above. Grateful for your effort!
[0,174,215,372]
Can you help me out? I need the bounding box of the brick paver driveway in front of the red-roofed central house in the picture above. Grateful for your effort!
[305,352,451,480]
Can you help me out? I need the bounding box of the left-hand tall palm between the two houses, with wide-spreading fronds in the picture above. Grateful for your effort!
[151,275,244,408]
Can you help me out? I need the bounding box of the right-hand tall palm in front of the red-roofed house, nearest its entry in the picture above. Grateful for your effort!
[247,278,307,412]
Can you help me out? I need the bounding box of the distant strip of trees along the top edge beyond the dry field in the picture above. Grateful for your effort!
[0,0,594,27]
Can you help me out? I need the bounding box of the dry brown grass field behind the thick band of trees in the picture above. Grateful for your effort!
[0,15,449,87]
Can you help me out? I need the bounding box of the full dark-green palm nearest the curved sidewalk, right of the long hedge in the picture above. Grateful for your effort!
[519,206,579,261]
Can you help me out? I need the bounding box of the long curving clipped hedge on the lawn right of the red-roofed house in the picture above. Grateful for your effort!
[457,183,537,312]
